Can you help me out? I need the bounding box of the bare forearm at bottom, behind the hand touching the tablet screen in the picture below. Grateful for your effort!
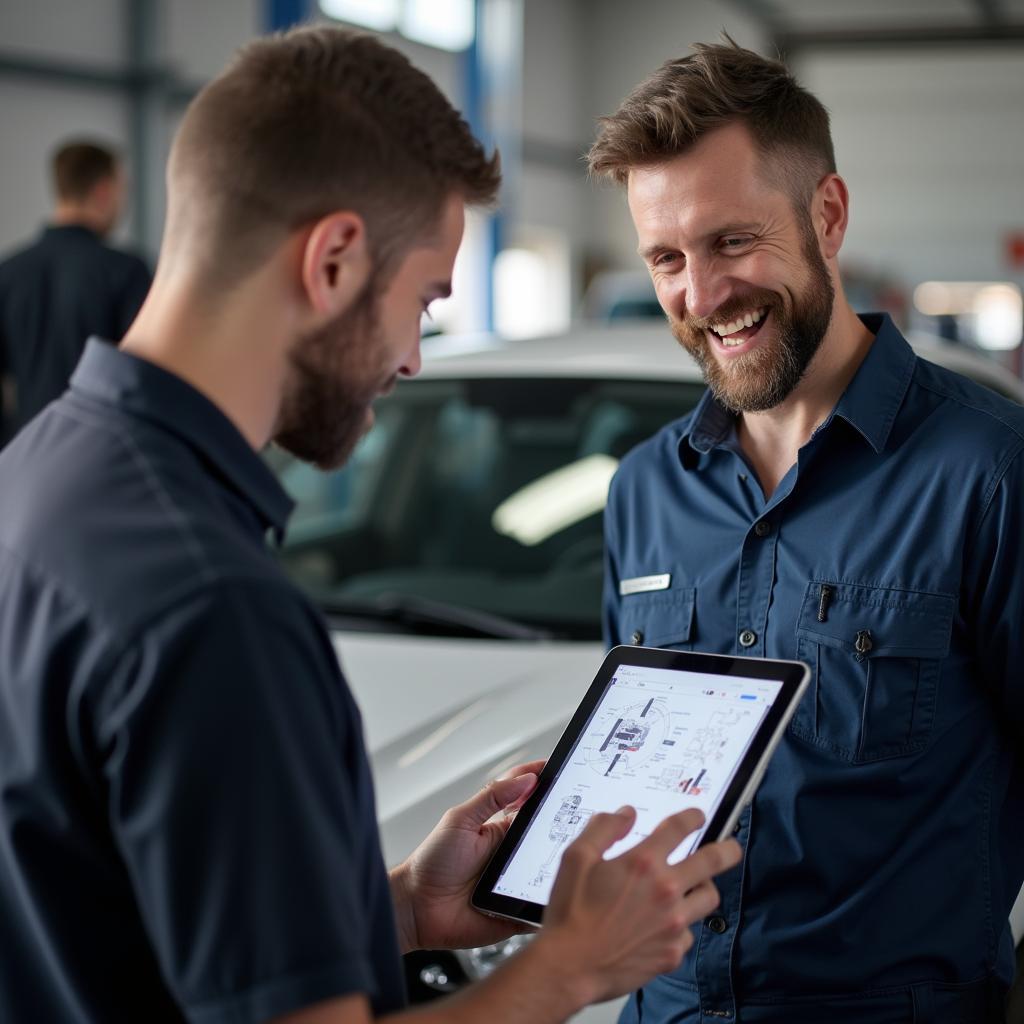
[380,933,597,1024]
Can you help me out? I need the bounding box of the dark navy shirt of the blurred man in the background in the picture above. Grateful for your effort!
[0,224,150,441]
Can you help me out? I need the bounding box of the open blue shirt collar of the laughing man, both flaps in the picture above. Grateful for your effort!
[680,313,916,465]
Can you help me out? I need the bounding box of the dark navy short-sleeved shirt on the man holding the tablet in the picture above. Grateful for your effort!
[0,340,404,1024]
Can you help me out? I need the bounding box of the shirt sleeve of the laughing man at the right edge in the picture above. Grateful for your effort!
[964,442,1024,739]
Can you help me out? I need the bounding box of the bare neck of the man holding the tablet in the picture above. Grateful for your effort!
[121,256,294,451]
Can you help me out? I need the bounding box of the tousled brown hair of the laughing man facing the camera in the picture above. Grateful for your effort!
[588,36,836,206]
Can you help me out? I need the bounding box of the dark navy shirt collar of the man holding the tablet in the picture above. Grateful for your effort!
[71,338,294,543]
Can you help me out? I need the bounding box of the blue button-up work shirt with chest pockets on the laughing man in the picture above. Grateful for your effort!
[605,316,1024,1024]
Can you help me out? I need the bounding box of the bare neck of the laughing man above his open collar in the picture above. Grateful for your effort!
[737,291,874,499]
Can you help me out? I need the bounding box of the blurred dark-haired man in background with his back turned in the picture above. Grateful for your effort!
[0,141,150,433]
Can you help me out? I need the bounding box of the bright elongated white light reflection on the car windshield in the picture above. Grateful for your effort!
[490,455,618,547]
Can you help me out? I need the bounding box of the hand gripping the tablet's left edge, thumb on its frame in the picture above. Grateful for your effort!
[391,761,544,952]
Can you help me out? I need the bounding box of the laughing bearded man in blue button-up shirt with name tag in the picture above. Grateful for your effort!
[590,45,1024,1024]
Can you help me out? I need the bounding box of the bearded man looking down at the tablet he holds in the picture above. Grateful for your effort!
[0,22,739,1024]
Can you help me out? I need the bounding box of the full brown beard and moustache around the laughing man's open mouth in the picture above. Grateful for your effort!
[669,217,836,413]
